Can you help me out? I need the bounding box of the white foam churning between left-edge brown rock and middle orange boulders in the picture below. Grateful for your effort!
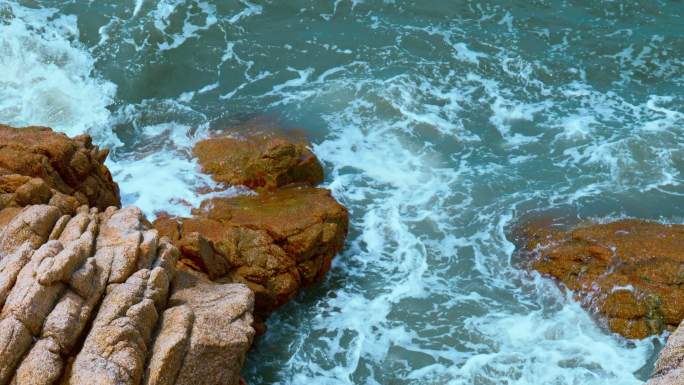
[107,97,238,219]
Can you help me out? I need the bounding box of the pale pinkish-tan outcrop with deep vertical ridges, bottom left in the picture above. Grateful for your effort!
[0,205,254,385]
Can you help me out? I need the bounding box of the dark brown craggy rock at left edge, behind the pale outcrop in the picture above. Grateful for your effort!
[0,125,121,213]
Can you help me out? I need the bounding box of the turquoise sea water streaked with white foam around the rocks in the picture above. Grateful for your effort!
[0,0,684,385]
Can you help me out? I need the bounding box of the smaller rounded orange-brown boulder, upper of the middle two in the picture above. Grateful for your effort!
[193,130,323,190]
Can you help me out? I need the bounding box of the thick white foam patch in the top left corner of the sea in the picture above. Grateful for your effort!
[0,2,120,146]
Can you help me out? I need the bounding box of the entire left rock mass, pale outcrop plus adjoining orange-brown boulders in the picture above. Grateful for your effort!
[0,126,349,385]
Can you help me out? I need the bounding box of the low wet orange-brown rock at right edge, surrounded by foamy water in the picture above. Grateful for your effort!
[523,220,684,338]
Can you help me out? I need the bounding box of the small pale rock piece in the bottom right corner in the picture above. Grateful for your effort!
[646,323,684,385]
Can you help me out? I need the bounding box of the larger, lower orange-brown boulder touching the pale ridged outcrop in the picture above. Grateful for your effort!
[154,187,349,318]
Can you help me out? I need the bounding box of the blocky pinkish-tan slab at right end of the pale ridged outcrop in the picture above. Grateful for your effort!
[154,271,254,385]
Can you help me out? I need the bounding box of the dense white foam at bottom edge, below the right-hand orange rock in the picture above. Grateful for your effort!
[460,293,651,385]
